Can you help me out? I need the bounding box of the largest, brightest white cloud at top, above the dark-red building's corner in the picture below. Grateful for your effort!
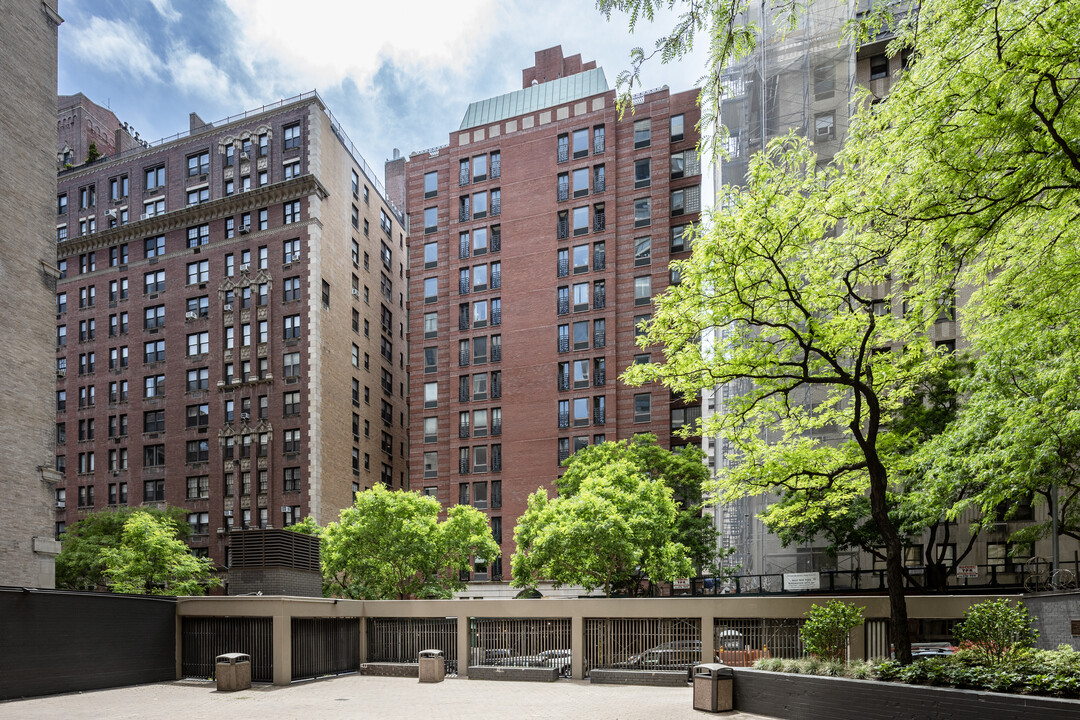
[225,0,496,94]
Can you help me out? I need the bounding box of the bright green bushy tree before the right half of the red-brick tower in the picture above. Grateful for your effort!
[510,456,692,597]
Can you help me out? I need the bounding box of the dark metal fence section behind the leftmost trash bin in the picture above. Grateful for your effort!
[180,617,273,682]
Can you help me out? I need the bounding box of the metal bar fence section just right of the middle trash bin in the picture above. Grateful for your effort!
[469,617,570,677]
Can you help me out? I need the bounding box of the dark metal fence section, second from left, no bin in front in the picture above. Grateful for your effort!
[292,617,360,680]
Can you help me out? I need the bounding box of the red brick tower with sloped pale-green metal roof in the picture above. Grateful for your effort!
[387,46,701,581]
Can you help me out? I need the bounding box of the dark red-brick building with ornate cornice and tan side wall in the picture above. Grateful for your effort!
[55,93,408,563]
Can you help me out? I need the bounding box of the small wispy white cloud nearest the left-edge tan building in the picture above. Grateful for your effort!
[62,16,161,80]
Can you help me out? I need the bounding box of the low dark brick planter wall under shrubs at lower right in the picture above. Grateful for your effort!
[734,668,1080,720]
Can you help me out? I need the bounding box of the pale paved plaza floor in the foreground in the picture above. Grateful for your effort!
[0,675,761,720]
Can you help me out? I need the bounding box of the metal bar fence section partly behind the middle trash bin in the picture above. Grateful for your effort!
[367,617,458,676]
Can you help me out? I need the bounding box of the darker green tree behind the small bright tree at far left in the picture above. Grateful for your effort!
[56,507,191,590]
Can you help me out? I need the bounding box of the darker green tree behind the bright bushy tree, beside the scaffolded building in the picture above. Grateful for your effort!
[555,433,729,580]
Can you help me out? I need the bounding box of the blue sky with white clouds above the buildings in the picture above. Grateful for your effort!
[58,0,704,172]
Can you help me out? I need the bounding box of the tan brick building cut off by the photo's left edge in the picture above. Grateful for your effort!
[0,0,63,587]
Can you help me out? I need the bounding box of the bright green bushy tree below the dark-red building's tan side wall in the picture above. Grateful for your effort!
[320,485,500,600]
